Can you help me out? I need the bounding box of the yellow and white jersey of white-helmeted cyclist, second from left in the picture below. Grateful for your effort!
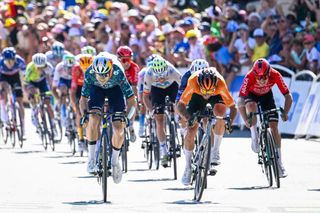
[24,62,53,83]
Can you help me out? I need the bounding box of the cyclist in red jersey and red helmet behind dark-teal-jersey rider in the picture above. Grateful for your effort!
[117,46,140,142]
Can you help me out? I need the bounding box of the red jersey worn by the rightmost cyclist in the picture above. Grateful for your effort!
[239,68,289,97]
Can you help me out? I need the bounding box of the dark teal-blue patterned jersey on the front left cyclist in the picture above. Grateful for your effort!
[81,63,134,99]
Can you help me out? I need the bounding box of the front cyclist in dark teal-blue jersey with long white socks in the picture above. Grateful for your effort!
[80,54,136,183]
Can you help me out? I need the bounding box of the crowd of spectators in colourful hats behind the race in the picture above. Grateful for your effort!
[0,0,320,88]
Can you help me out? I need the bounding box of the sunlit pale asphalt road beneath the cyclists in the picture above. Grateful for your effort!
[0,112,320,213]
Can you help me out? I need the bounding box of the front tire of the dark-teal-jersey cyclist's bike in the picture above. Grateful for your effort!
[101,135,108,203]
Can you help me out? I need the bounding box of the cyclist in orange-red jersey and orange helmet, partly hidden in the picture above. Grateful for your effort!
[70,54,93,152]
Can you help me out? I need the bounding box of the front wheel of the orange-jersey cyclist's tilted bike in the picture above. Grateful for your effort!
[194,135,211,202]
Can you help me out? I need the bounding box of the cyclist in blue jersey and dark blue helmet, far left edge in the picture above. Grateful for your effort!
[0,47,26,136]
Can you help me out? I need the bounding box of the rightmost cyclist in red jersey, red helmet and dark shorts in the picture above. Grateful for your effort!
[238,58,292,177]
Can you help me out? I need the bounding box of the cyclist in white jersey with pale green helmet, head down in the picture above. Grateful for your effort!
[143,56,181,167]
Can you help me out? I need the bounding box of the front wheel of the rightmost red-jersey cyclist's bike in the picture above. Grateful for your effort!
[260,132,273,187]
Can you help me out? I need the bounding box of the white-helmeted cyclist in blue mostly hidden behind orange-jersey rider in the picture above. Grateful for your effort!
[176,59,209,141]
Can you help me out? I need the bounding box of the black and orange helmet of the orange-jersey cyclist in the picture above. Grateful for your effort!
[198,69,218,93]
